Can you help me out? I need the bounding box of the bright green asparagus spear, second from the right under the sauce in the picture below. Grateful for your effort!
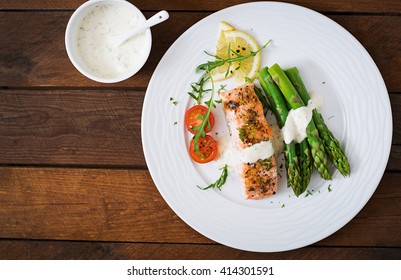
[268,64,331,180]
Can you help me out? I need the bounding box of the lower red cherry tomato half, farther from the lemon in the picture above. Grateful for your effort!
[189,135,218,163]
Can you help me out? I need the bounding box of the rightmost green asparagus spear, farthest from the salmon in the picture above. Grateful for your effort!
[285,67,350,177]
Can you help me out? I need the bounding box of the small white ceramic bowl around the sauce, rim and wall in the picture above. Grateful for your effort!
[65,0,152,83]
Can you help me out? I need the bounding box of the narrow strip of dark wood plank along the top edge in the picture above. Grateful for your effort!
[0,0,401,13]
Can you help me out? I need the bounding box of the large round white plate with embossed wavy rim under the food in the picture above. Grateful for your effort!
[142,2,392,252]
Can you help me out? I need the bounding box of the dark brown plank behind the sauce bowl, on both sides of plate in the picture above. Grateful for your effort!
[0,12,401,92]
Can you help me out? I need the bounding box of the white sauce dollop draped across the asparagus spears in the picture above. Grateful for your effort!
[281,92,323,144]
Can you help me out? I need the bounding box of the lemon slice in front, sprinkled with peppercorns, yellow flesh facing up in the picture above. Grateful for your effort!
[224,30,260,84]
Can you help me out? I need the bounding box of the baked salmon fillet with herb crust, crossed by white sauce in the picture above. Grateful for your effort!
[220,83,278,199]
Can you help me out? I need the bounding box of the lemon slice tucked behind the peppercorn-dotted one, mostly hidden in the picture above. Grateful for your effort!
[210,21,234,82]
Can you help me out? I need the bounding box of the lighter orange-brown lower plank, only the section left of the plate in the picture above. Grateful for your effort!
[0,167,210,243]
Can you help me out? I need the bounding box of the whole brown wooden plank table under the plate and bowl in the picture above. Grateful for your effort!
[0,0,401,259]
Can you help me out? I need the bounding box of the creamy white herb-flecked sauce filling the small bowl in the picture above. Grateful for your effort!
[77,2,147,78]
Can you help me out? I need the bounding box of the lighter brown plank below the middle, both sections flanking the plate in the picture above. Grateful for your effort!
[0,167,401,247]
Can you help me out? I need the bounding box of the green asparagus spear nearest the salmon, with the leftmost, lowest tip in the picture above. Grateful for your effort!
[258,67,304,196]
